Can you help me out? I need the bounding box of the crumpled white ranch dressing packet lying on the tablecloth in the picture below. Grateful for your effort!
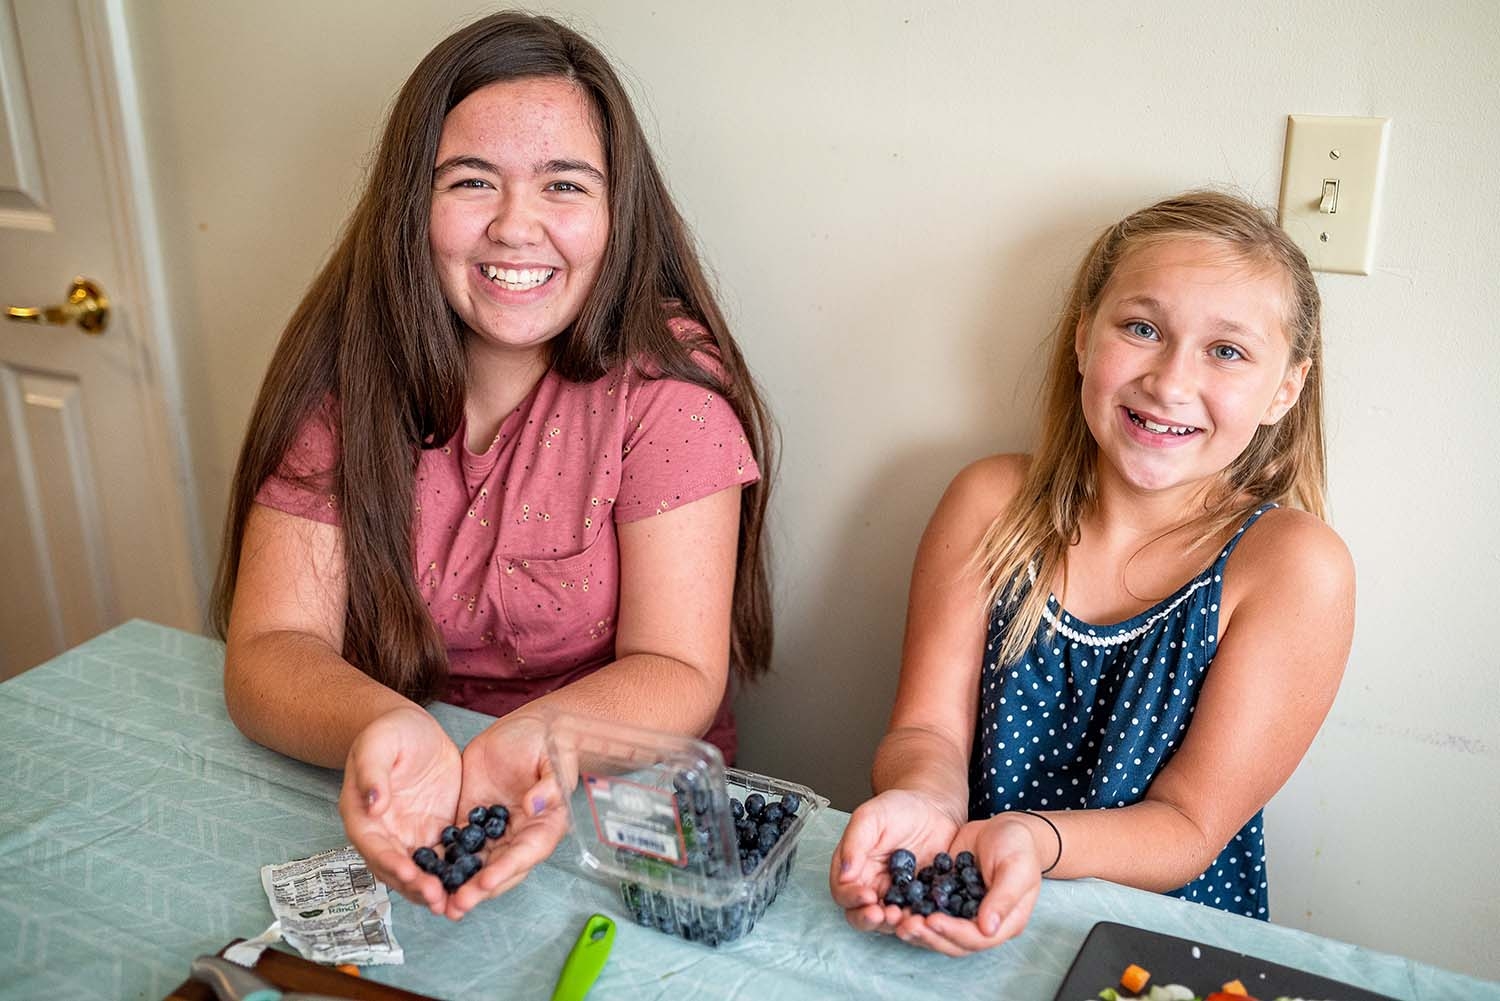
[261,845,405,966]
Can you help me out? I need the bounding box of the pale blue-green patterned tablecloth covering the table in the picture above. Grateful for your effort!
[0,621,1500,1001]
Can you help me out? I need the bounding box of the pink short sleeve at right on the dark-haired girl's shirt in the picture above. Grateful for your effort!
[615,378,761,522]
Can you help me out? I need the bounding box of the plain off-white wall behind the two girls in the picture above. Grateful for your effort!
[123,0,1500,978]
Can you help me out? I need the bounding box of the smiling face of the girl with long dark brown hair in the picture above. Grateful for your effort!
[428,77,609,354]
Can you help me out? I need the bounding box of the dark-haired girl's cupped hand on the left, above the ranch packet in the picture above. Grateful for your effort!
[339,705,464,914]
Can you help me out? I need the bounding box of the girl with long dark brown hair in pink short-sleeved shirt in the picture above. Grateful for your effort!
[213,12,773,918]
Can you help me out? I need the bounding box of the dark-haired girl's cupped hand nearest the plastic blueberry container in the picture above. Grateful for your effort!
[446,714,567,920]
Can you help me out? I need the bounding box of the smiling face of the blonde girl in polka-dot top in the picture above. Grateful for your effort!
[1074,239,1308,501]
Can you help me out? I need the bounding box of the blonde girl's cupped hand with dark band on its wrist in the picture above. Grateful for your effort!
[896,813,1043,956]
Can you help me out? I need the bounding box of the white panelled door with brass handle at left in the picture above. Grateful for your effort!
[0,0,201,678]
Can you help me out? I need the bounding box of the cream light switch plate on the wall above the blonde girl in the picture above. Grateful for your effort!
[1280,114,1391,275]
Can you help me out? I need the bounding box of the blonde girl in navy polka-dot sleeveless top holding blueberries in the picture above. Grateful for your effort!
[830,192,1355,954]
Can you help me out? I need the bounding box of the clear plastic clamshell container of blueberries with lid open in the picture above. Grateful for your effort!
[548,713,828,945]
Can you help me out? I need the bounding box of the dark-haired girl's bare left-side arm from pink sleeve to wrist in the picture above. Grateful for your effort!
[224,504,420,768]
